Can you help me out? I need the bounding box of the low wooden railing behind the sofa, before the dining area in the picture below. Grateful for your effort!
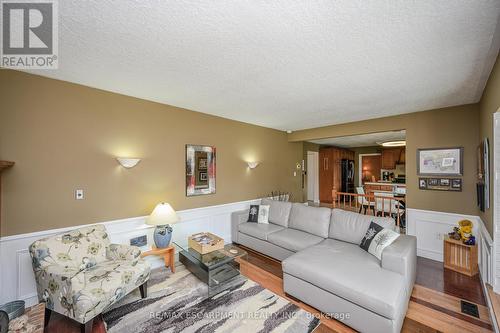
[332,189,405,227]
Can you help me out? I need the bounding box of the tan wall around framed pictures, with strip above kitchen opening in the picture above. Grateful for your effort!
[288,104,479,215]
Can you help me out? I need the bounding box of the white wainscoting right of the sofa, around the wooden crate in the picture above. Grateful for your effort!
[406,208,494,284]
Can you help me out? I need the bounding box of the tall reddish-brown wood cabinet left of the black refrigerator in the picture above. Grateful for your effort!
[319,147,354,203]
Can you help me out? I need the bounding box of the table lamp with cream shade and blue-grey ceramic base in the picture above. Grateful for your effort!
[146,202,179,249]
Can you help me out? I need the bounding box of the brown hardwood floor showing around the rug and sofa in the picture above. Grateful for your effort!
[46,247,492,333]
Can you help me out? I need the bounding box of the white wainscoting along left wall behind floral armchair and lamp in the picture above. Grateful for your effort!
[0,199,260,305]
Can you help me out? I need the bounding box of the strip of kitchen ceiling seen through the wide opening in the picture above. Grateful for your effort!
[309,130,406,148]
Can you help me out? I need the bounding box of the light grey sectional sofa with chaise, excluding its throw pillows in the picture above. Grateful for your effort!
[231,199,417,333]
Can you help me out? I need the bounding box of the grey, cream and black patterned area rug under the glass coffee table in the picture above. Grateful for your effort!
[103,265,319,333]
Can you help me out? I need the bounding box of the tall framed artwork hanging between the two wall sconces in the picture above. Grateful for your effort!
[186,145,216,197]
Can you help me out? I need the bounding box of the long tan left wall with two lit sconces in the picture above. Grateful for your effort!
[0,70,302,236]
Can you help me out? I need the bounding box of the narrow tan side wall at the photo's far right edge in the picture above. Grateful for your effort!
[479,54,500,235]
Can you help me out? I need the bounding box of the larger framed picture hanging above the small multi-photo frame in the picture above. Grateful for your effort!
[417,147,464,176]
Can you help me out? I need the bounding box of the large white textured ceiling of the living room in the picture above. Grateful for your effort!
[26,0,500,130]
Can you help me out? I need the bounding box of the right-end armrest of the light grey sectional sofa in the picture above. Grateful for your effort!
[382,235,417,295]
